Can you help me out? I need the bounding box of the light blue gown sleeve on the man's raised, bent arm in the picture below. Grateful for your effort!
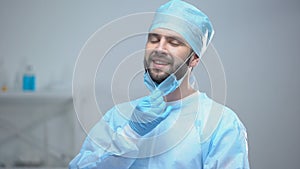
[69,106,138,169]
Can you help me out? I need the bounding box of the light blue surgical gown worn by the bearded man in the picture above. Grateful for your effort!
[69,91,249,169]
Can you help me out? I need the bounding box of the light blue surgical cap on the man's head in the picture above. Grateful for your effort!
[149,0,214,58]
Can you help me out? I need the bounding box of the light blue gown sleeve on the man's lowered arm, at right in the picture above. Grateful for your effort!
[204,109,249,169]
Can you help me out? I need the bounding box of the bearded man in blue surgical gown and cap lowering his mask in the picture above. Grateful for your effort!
[69,0,249,169]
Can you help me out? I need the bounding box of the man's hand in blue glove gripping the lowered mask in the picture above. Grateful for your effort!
[129,90,171,136]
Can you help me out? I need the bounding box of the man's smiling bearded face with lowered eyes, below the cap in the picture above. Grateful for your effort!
[144,28,192,83]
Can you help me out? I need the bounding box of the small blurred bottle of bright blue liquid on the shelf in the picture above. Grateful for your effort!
[23,65,36,91]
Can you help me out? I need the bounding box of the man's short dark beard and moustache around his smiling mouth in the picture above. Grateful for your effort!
[144,51,189,84]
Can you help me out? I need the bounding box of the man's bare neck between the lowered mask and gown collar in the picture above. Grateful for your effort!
[165,74,196,102]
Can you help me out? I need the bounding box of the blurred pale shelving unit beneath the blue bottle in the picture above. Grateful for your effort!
[0,91,76,169]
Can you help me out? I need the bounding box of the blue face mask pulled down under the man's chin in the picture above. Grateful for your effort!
[144,52,194,96]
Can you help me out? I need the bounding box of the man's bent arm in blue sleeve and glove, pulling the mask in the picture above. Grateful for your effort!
[69,91,171,169]
